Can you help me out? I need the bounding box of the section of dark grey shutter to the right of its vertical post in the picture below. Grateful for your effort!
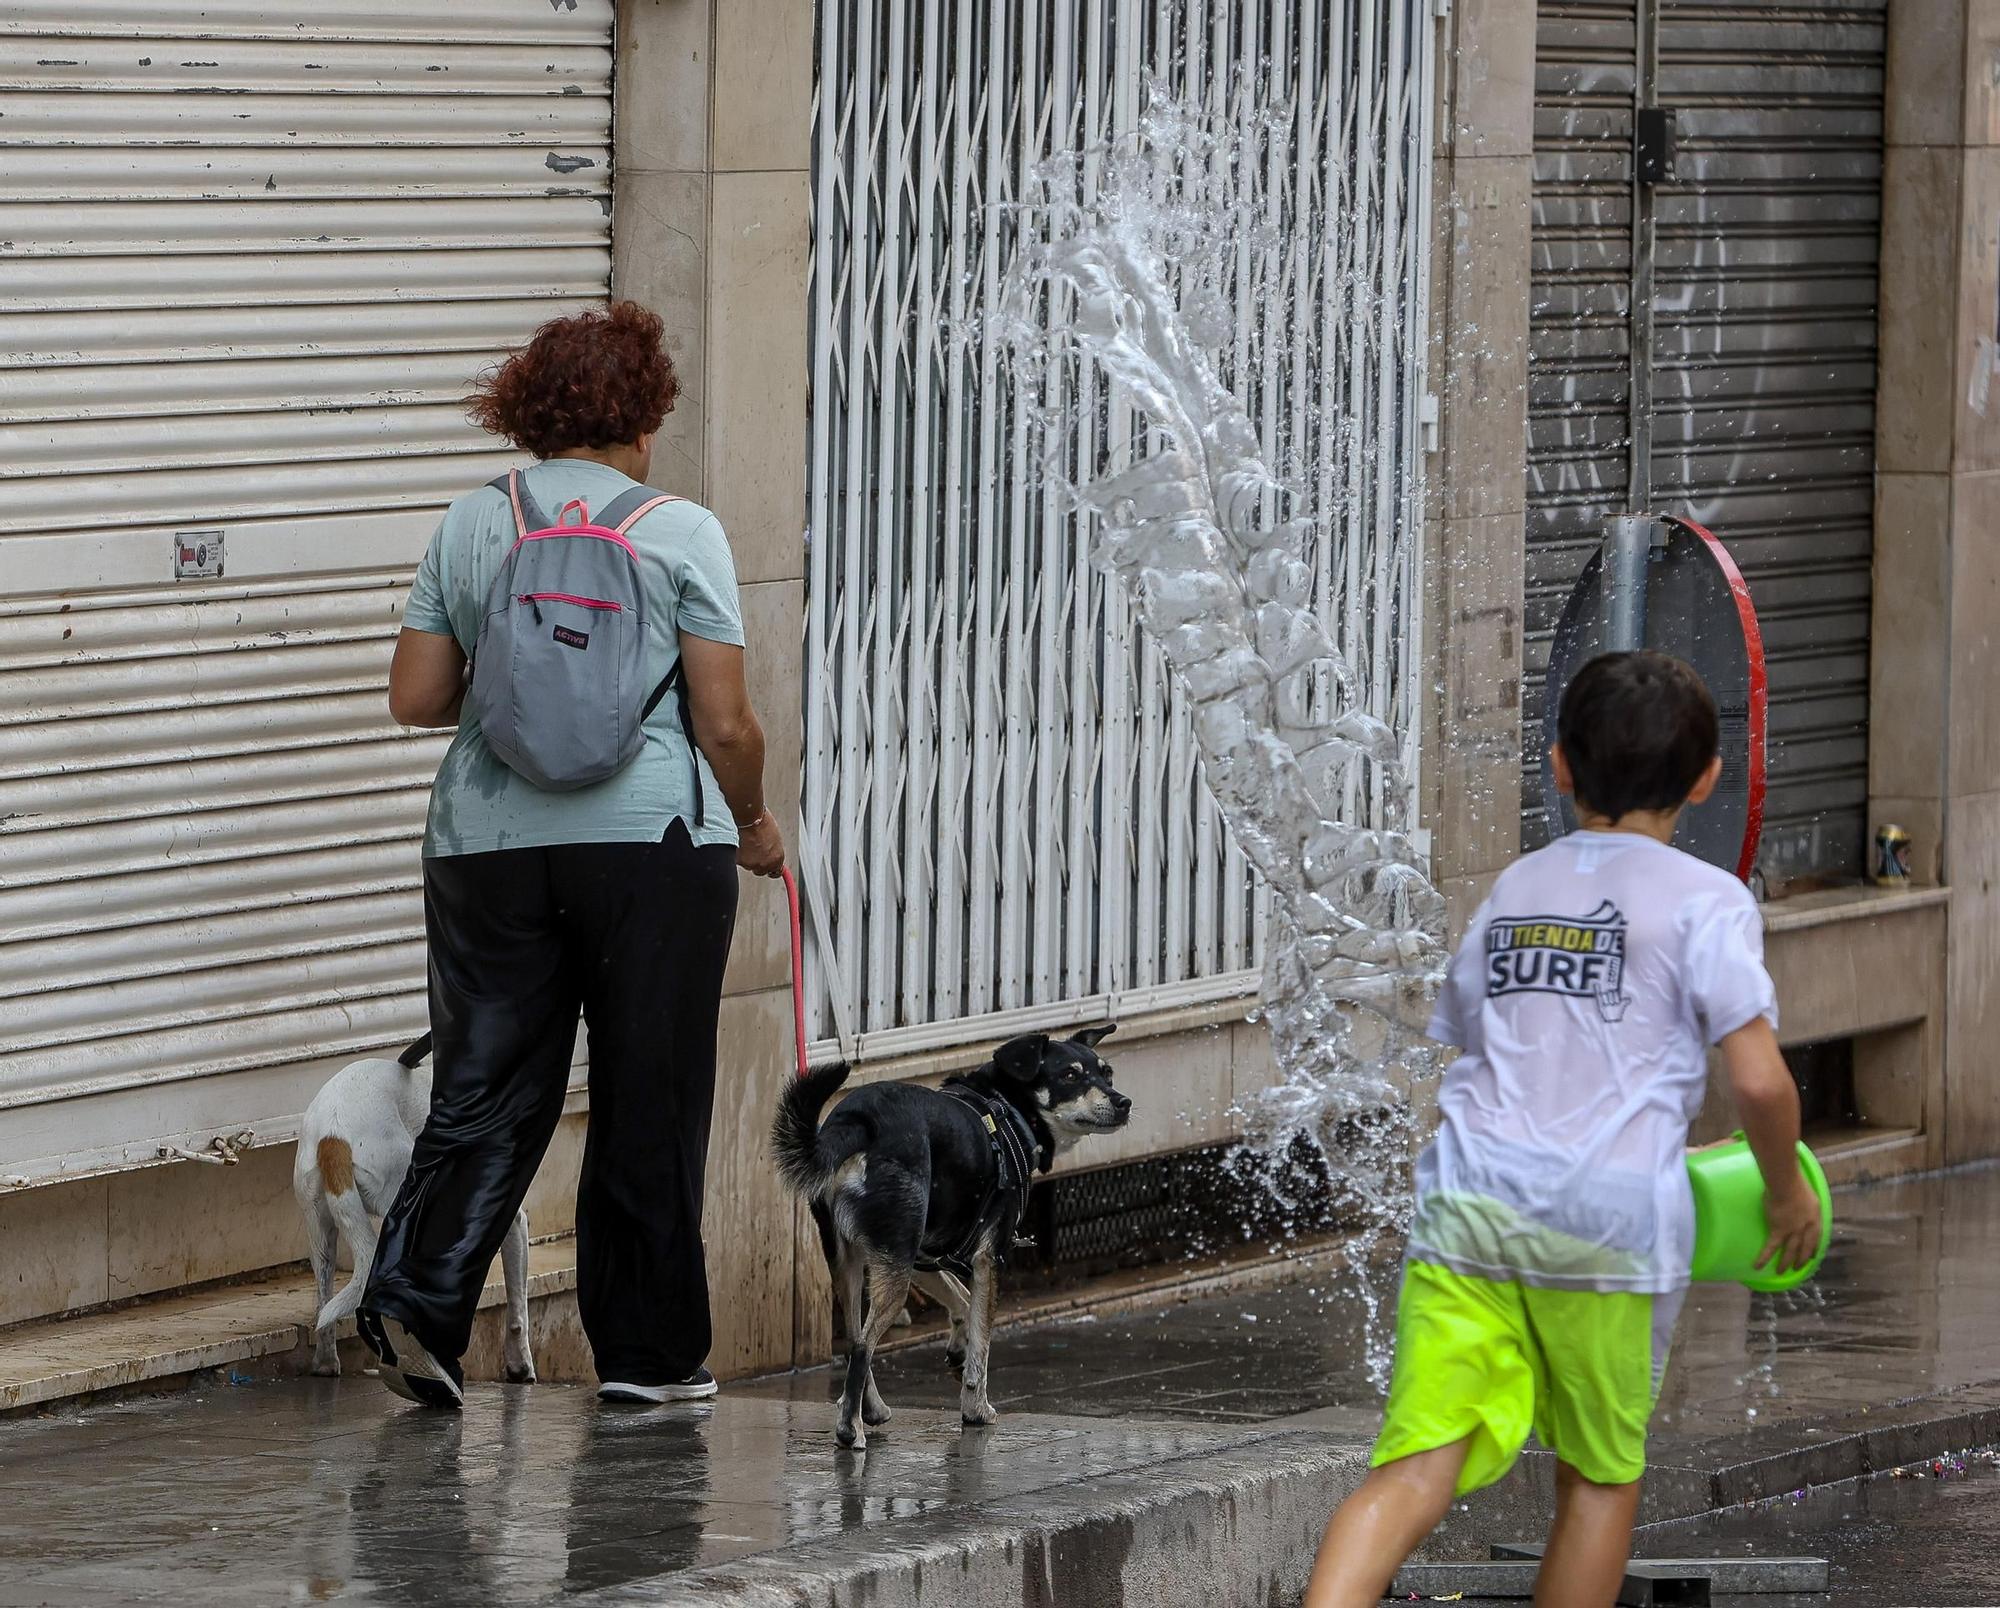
[1652,0,1884,876]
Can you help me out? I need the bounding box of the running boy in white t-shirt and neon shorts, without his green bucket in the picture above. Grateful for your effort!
[1306,652,1820,1608]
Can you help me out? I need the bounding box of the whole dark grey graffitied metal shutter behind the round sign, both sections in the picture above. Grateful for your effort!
[1524,0,1884,876]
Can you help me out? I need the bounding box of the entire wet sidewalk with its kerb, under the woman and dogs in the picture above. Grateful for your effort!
[0,1172,2000,1608]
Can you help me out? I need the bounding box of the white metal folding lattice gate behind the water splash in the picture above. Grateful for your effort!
[800,0,1434,1056]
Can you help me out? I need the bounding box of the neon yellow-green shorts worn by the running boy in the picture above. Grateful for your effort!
[1372,1262,1682,1496]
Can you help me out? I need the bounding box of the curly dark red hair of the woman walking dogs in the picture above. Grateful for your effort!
[466,302,680,458]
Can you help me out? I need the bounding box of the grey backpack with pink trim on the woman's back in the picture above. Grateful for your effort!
[466,470,700,808]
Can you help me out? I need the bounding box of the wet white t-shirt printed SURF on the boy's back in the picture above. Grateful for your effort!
[1410,832,1778,1294]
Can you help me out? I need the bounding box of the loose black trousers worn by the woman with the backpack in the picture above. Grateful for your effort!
[362,820,736,1384]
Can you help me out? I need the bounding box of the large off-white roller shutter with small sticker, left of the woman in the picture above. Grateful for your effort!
[0,0,612,1184]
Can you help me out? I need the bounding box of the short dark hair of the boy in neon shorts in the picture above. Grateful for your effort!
[1556,650,1718,820]
